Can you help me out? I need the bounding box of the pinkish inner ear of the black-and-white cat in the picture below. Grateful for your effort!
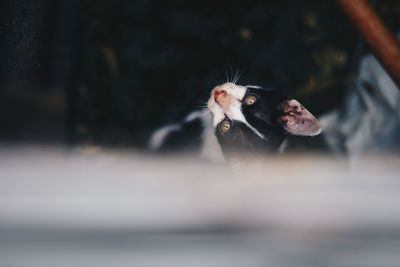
[279,99,321,136]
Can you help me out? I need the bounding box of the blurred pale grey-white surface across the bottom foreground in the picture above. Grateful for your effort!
[0,147,400,267]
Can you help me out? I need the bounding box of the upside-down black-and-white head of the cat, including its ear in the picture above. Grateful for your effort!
[208,83,321,154]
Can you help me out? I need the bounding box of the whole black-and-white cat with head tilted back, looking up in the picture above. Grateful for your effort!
[150,83,321,161]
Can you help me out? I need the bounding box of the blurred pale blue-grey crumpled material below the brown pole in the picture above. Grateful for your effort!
[319,55,400,156]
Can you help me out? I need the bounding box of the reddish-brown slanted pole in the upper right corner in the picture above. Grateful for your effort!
[336,0,400,88]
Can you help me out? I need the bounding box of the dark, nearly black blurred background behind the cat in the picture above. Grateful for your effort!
[0,0,400,148]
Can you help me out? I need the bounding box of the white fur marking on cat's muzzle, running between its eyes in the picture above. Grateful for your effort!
[208,83,264,138]
